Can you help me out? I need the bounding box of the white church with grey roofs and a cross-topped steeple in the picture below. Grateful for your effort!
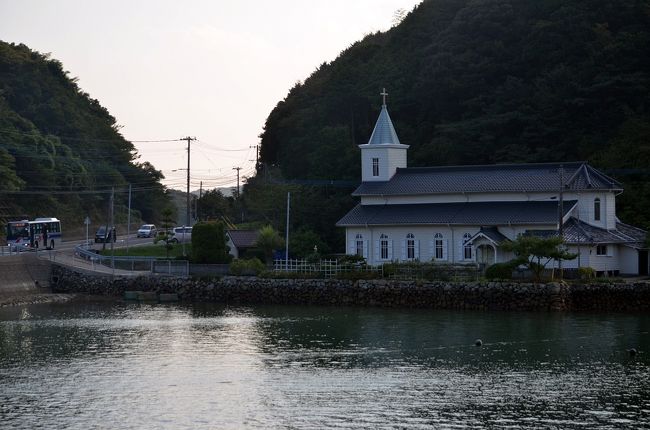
[336,92,648,276]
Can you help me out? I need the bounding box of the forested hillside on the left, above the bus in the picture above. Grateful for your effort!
[0,42,168,235]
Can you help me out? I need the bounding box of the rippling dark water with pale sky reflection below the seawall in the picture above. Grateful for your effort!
[0,303,650,429]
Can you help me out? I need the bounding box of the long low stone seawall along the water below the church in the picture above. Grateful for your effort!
[52,266,650,311]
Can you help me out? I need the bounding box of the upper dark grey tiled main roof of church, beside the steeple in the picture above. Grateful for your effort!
[352,162,622,196]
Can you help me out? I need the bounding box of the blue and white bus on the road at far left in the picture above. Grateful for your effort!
[7,218,61,251]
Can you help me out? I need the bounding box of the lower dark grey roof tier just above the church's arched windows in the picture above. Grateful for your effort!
[336,201,576,227]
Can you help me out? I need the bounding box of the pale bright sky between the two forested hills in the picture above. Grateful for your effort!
[0,0,421,190]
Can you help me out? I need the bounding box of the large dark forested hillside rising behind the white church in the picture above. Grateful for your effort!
[261,0,650,245]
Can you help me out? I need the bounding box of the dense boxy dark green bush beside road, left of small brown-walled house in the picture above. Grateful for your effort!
[192,221,231,264]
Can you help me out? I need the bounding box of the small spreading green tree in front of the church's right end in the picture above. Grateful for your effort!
[501,235,578,282]
